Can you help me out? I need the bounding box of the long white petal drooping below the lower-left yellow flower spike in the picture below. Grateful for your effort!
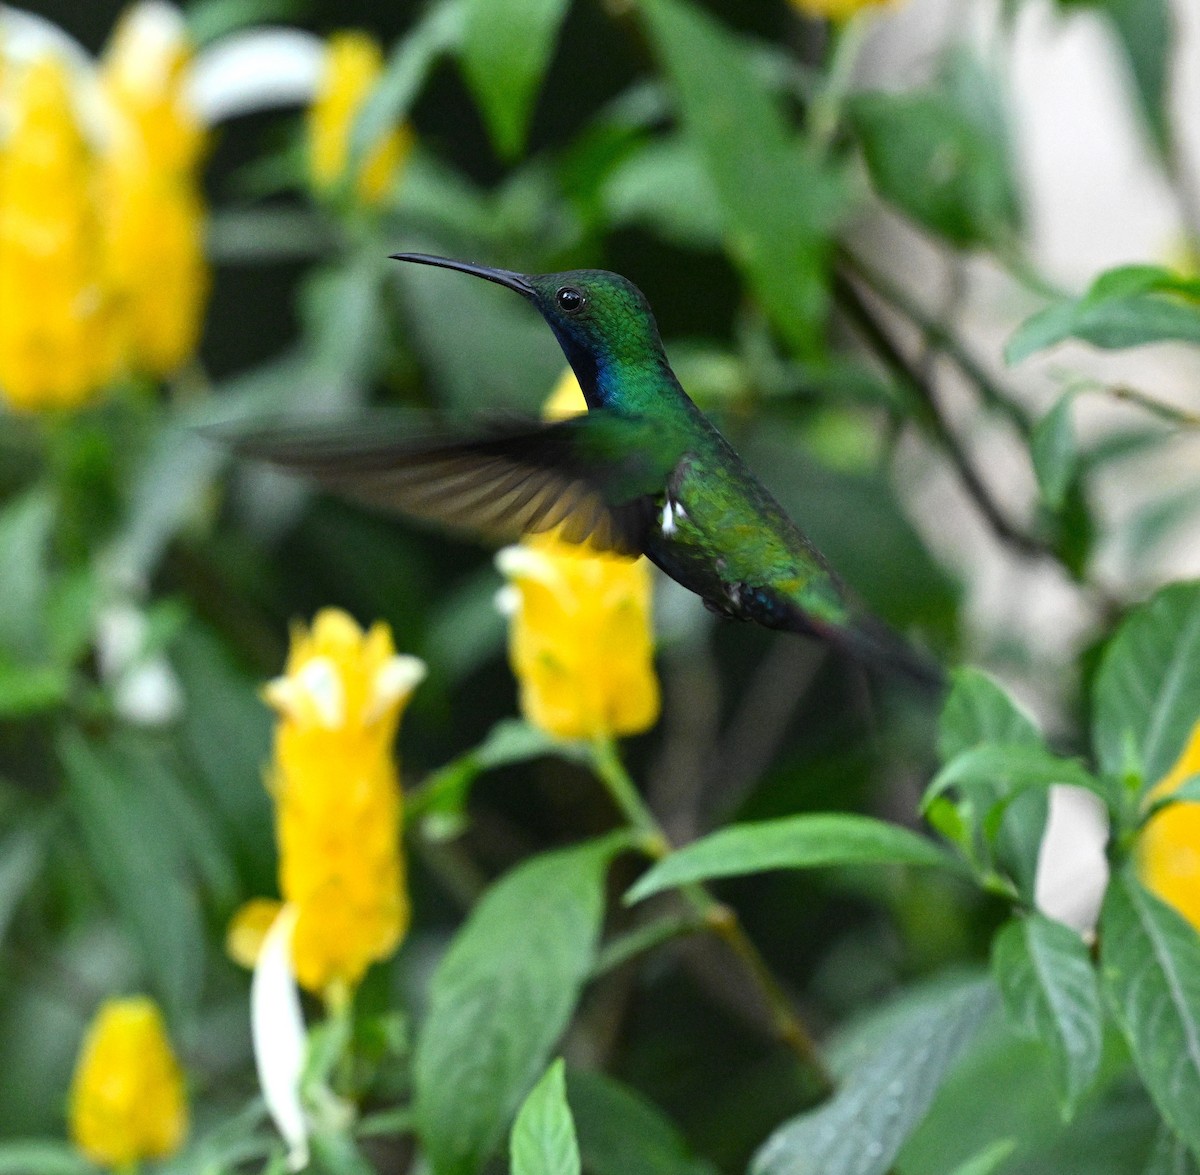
[250,905,308,1171]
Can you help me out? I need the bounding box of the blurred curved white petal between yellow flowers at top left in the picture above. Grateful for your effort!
[185,29,325,125]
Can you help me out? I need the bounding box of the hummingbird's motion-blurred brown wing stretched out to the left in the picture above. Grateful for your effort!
[210,410,684,554]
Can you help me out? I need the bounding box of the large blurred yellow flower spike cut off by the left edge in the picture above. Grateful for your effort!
[0,56,120,409]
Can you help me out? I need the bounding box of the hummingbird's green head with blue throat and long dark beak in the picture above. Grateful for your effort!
[392,253,666,407]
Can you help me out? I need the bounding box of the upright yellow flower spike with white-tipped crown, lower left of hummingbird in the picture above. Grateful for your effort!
[228,609,425,999]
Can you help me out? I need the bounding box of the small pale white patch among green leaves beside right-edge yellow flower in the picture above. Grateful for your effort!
[1033,785,1109,934]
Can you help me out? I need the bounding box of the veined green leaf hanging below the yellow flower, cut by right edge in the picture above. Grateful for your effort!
[1099,869,1200,1155]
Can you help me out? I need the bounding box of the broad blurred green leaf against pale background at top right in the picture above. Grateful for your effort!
[850,53,1020,248]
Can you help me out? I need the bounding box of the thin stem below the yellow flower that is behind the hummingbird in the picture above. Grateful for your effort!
[592,736,834,1095]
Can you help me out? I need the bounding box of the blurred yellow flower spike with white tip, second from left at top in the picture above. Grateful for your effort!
[101,2,209,376]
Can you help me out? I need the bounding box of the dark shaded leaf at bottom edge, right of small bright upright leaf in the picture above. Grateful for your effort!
[566,1069,715,1175]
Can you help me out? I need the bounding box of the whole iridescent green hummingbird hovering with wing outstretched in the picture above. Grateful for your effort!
[225,253,941,685]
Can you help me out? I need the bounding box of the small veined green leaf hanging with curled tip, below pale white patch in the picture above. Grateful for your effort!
[991,913,1104,1116]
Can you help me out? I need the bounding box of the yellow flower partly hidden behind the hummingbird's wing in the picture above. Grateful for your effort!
[497,371,659,738]
